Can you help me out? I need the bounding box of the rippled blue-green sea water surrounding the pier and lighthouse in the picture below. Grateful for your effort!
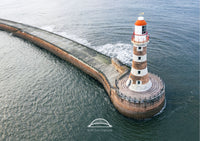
[0,0,200,141]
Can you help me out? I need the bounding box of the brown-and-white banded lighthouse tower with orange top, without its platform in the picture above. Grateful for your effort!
[126,16,152,92]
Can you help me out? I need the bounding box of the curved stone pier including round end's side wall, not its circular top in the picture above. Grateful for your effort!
[0,20,165,119]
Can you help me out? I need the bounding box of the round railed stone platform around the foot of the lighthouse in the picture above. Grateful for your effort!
[110,73,165,119]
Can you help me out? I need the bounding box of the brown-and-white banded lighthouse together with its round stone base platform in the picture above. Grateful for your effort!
[113,16,165,119]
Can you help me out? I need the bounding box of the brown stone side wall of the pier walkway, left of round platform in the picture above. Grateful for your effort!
[0,24,110,95]
